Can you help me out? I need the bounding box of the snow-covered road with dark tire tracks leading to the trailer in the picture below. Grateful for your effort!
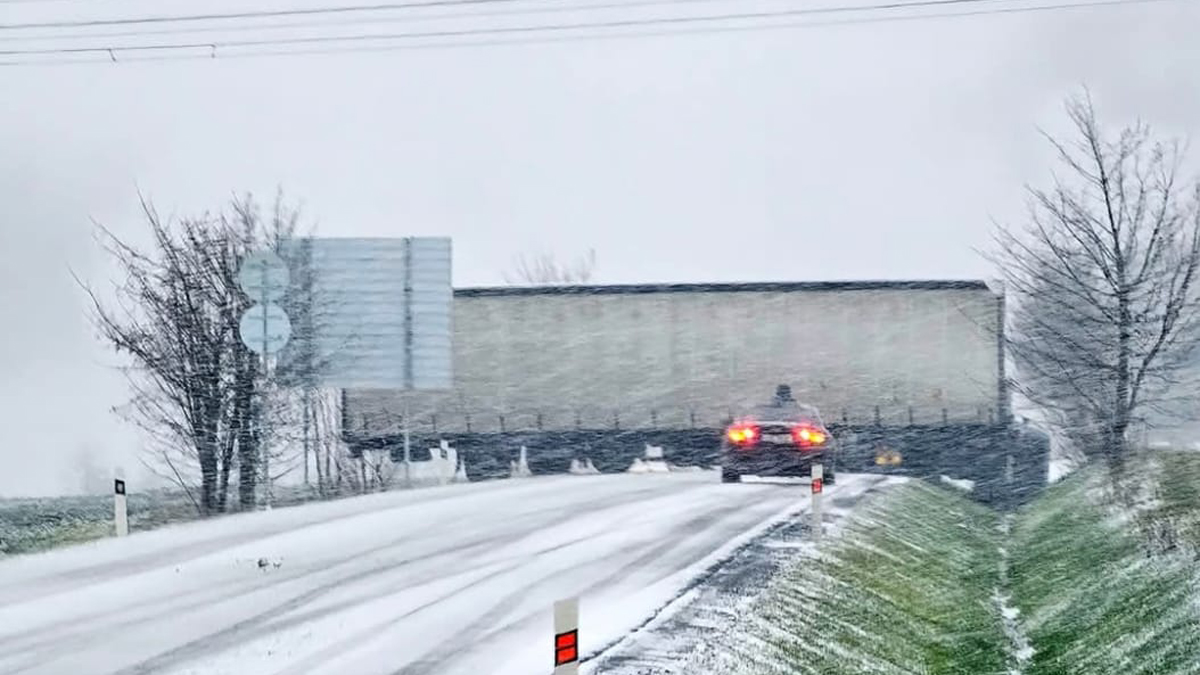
[0,472,877,675]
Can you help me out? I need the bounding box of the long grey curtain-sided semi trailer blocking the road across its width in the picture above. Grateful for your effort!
[342,281,1049,502]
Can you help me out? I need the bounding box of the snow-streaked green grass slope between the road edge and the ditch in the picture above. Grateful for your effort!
[713,482,1012,675]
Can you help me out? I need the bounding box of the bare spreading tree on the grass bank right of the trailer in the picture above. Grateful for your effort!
[992,95,1200,476]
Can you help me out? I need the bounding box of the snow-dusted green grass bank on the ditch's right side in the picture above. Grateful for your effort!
[1009,470,1200,675]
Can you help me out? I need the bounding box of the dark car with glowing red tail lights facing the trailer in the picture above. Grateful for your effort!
[721,384,836,484]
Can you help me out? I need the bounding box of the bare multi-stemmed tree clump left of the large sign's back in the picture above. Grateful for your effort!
[79,196,309,515]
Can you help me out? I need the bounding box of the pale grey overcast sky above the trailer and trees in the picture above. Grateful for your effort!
[0,0,1200,495]
